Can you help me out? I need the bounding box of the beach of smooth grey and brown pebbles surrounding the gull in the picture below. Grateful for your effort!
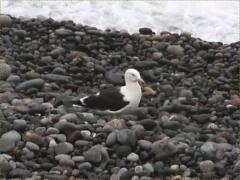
[0,15,240,180]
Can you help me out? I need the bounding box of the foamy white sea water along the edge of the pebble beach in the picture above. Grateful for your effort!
[0,0,240,43]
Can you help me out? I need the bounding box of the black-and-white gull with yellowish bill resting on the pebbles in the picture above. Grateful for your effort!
[73,69,148,113]
